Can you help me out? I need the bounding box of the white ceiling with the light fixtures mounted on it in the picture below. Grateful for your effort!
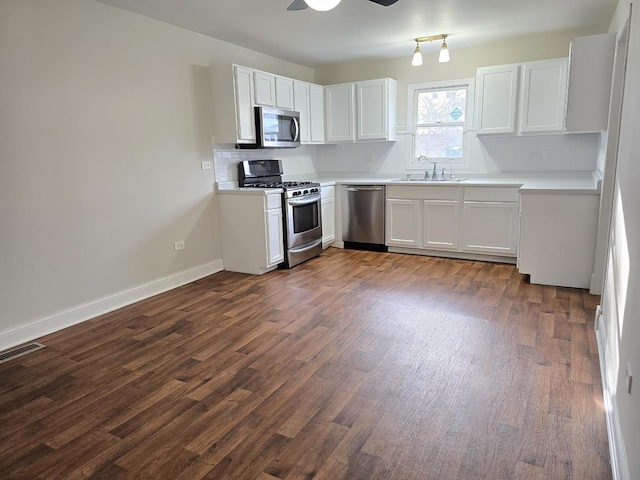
[92,0,617,67]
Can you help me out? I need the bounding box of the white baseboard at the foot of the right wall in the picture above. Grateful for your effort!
[596,320,631,480]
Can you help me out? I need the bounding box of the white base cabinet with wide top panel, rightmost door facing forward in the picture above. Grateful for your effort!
[462,187,520,256]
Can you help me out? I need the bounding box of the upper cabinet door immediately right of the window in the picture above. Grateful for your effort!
[475,64,520,135]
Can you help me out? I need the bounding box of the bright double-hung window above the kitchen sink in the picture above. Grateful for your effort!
[407,79,473,168]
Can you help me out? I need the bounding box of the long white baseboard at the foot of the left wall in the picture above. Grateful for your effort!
[0,259,224,351]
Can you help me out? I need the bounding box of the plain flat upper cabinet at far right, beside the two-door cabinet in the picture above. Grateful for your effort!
[565,33,616,132]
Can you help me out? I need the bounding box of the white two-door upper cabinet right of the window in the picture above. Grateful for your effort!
[476,58,567,135]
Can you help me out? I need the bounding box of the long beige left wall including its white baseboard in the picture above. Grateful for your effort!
[0,0,313,350]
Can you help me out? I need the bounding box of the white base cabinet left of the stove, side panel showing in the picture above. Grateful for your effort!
[218,190,284,275]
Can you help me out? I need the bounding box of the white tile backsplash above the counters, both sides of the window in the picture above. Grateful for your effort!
[214,133,606,183]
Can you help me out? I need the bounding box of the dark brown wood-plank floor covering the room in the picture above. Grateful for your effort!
[0,248,611,480]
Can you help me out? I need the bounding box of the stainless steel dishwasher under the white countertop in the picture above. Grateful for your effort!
[342,185,387,252]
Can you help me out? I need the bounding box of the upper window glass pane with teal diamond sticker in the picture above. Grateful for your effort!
[416,88,467,125]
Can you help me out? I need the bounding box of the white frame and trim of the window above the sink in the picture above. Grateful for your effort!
[406,78,475,170]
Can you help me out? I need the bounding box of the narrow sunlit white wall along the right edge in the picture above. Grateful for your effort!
[599,0,640,480]
